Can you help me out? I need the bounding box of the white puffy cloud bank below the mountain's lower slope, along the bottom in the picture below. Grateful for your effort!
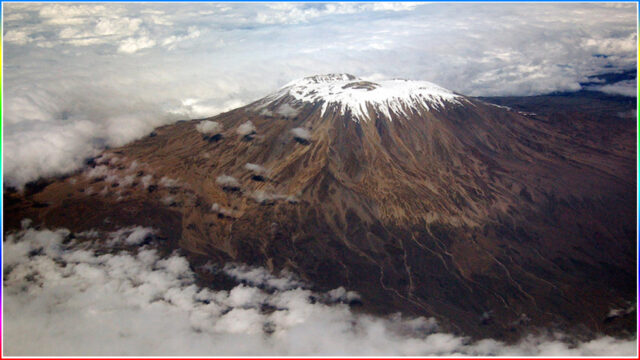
[3,223,636,356]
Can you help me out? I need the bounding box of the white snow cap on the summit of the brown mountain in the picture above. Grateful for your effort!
[263,74,464,121]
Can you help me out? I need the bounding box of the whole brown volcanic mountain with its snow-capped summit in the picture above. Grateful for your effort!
[4,74,636,339]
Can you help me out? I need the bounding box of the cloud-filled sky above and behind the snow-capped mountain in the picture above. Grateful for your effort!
[2,2,637,188]
